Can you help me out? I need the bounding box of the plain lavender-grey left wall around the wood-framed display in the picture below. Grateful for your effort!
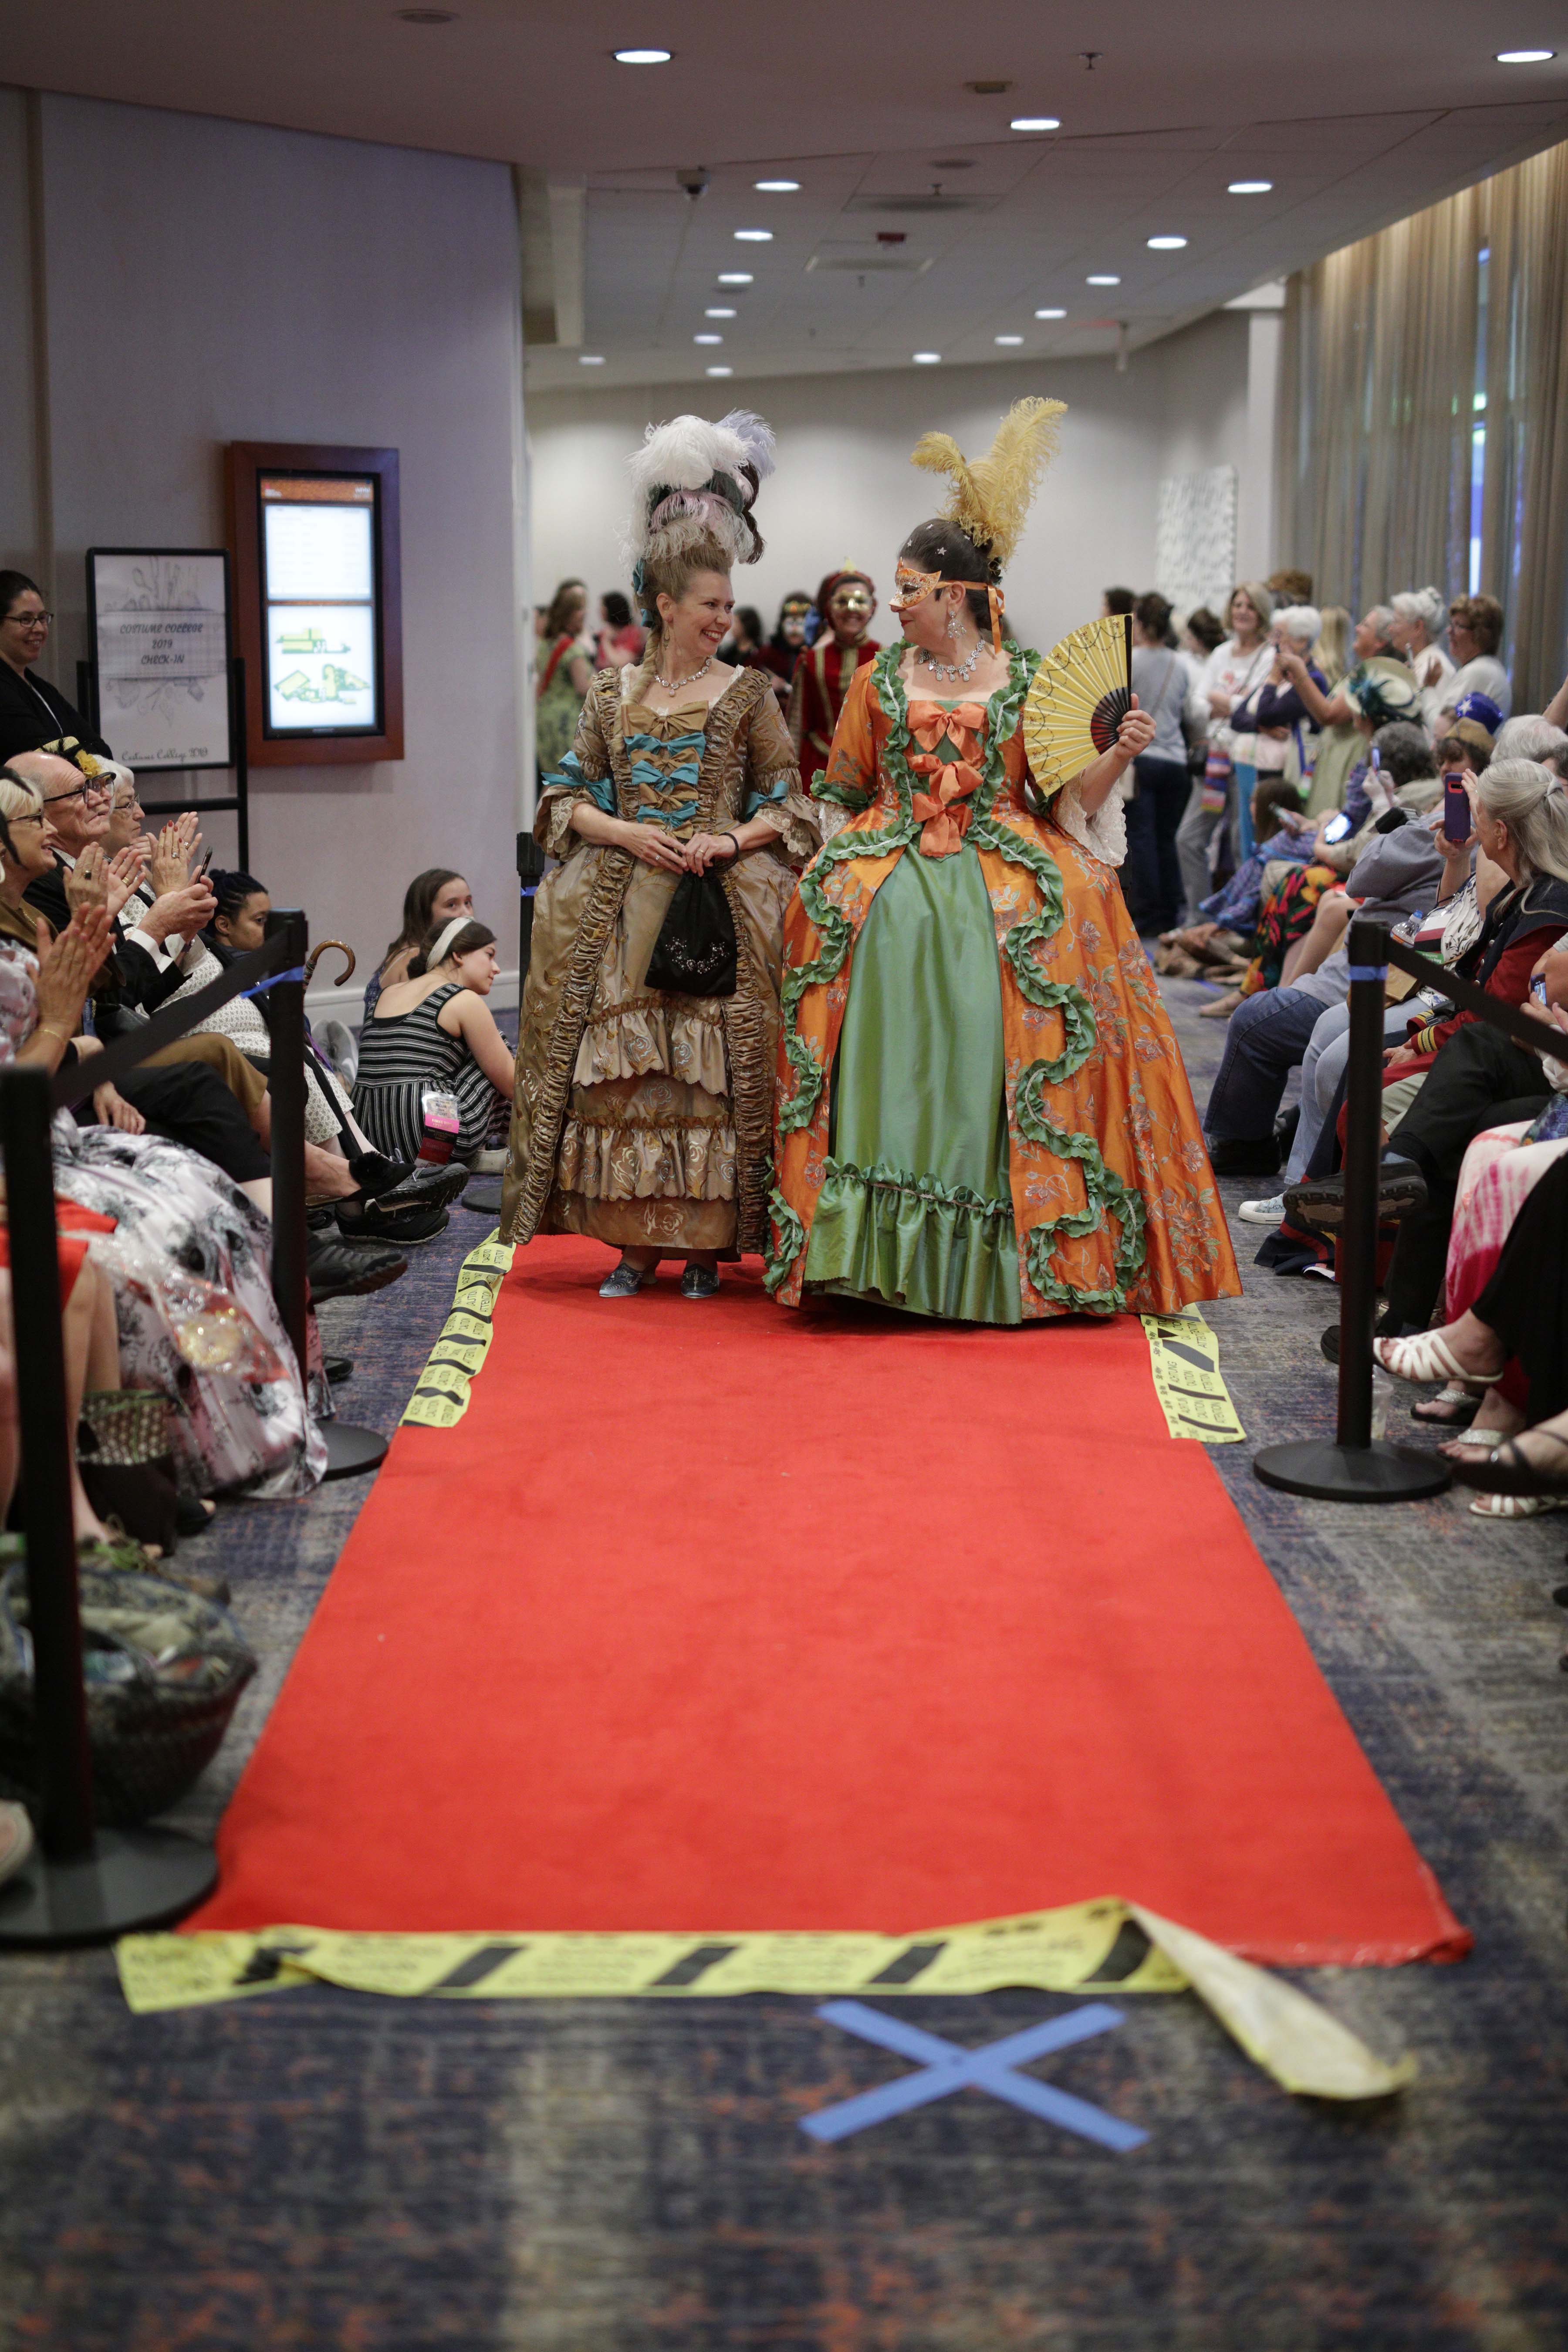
[0,92,522,992]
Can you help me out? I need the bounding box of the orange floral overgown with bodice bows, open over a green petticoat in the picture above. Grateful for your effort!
[767,645,1241,1322]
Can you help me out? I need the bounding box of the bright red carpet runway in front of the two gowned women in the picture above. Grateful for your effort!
[188,1240,1467,1964]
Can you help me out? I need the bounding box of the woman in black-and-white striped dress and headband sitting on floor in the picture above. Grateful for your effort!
[355,915,512,1166]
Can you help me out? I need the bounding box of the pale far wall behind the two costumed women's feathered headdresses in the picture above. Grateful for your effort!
[529,311,1255,668]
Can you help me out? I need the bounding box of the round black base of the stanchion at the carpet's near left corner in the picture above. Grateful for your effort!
[0,1830,219,1950]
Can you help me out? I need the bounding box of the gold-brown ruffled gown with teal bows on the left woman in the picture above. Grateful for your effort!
[501,670,818,1256]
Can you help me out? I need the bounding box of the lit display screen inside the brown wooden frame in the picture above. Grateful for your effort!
[256,473,381,736]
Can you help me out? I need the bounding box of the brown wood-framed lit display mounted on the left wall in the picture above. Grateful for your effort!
[226,442,402,767]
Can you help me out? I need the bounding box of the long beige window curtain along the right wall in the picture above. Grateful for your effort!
[1279,146,1568,710]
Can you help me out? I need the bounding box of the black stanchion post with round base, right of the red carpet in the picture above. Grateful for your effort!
[1253,919,1450,1503]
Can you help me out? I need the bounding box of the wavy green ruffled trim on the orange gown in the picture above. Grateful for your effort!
[764,640,1145,1315]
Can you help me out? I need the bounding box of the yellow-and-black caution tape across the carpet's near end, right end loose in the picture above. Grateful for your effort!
[115,1898,1415,2098]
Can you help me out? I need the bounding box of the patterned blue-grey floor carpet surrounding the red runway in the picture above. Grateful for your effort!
[0,983,1568,2352]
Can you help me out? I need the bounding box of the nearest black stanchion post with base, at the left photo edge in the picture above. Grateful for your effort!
[0,1068,219,1947]
